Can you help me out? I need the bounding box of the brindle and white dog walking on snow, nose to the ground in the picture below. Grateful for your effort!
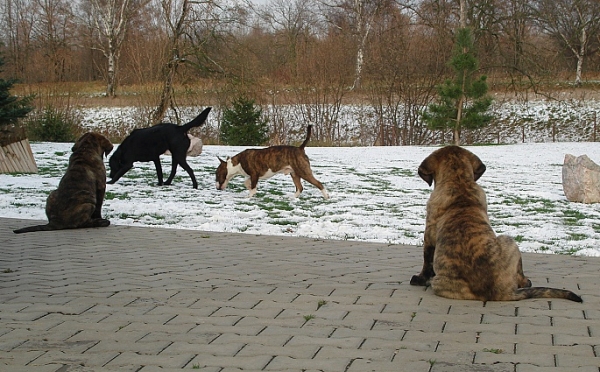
[217,125,329,199]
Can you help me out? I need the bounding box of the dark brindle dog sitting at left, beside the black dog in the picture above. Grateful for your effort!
[14,133,113,234]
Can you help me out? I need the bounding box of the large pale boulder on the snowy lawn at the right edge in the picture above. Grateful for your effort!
[563,154,600,203]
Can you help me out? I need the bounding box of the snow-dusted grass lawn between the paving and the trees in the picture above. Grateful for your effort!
[0,142,600,256]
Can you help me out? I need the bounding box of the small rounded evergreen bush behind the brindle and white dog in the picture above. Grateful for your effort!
[221,97,269,146]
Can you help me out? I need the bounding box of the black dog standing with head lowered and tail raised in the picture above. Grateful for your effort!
[107,107,211,189]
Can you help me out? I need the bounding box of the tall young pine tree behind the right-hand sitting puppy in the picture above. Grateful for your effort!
[423,28,493,145]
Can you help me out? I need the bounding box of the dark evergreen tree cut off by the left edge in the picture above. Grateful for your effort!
[0,57,33,144]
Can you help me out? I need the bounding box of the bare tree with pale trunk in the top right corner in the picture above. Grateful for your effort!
[531,0,600,85]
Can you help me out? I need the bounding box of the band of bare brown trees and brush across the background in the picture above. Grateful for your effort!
[0,0,600,145]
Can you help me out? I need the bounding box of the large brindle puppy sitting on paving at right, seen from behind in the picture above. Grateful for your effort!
[410,146,582,302]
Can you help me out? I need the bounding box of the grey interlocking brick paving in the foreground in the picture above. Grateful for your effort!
[0,218,600,372]
